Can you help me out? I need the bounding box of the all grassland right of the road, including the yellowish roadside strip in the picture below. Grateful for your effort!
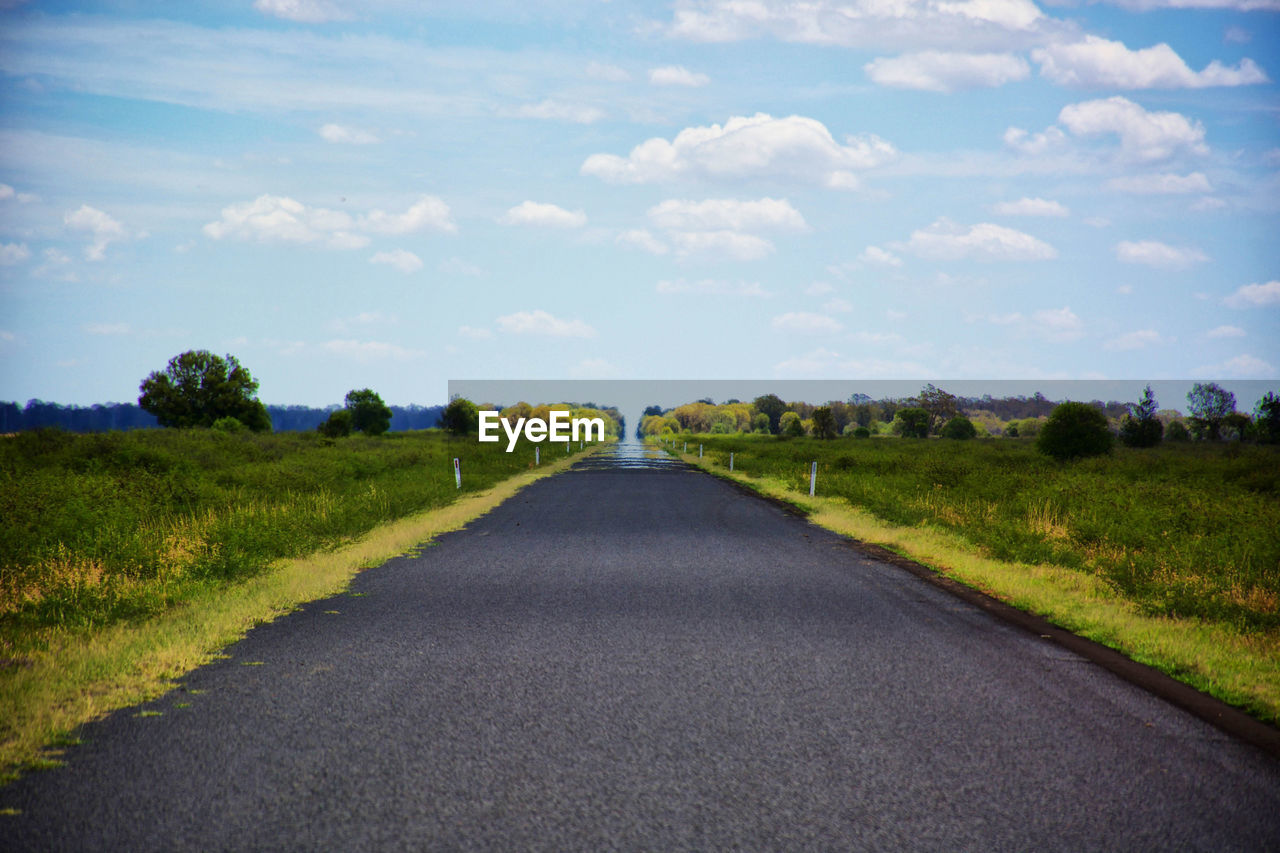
[675,435,1280,724]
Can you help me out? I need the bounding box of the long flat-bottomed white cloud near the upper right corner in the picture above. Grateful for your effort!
[1032,36,1267,88]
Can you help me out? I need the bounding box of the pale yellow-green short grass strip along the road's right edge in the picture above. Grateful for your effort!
[671,451,1280,725]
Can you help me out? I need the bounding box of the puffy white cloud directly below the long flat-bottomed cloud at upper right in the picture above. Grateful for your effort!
[1054,95,1208,160]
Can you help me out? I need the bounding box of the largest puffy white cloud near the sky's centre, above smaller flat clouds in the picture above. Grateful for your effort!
[581,113,897,190]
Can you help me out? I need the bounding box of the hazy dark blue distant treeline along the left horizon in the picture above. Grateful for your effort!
[0,400,444,433]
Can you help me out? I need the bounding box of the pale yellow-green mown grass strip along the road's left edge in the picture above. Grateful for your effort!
[0,451,590,784]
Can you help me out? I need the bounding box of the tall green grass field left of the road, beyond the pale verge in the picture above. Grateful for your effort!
[0,429,576,660]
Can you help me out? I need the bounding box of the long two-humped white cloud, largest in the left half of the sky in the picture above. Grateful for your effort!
[204,195,456,250]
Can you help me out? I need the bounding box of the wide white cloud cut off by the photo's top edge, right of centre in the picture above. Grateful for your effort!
[663,0,1046,50]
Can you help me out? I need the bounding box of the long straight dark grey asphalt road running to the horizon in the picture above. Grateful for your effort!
[0,440,1280,852]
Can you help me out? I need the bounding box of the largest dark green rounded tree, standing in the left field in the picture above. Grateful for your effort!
[138,350,271,433]
